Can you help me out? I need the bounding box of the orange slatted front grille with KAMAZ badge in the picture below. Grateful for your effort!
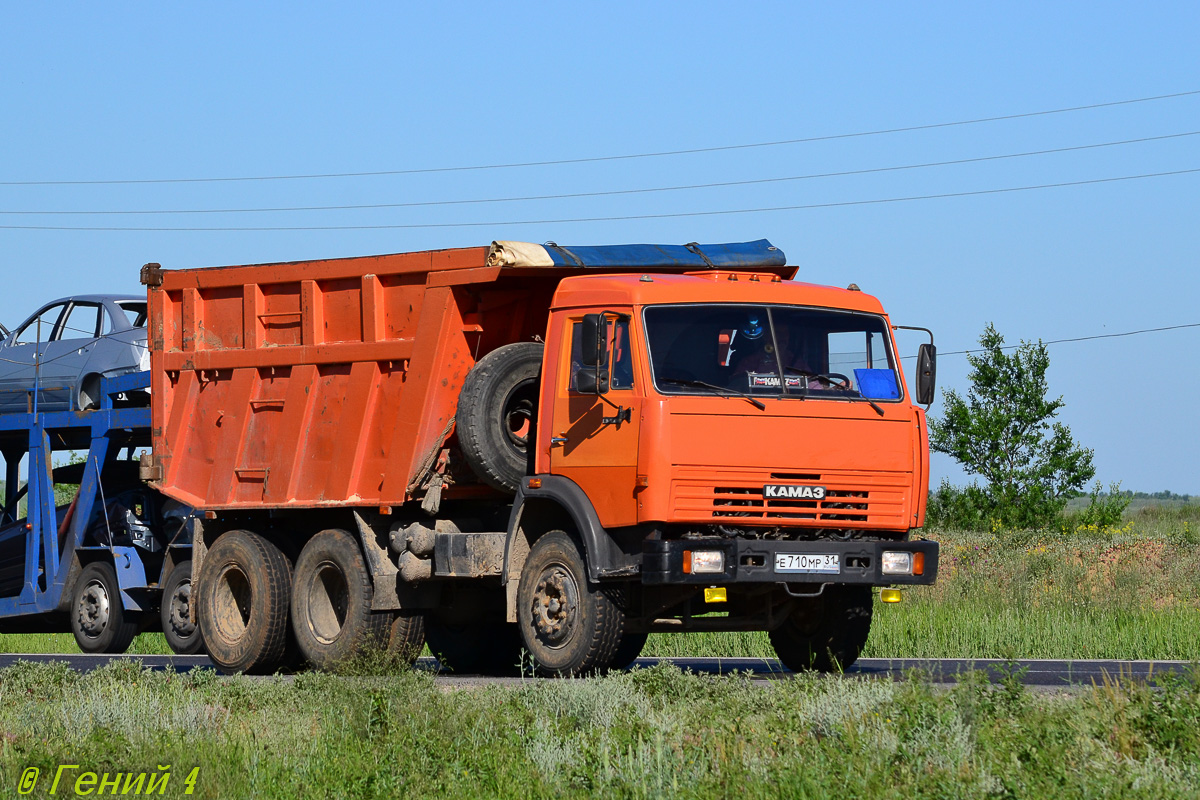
[672,470,910,528]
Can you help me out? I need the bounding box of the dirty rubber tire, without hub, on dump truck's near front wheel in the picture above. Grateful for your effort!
[517,530,625,678]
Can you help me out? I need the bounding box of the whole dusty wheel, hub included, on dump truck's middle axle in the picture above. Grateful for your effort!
[292,529,392,669]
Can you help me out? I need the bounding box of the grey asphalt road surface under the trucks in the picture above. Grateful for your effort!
[0,654,1190,687]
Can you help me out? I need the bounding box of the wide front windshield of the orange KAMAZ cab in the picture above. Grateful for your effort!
[643,303,901,401]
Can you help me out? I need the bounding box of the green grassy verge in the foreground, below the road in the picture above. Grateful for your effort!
[0,663,1200,800]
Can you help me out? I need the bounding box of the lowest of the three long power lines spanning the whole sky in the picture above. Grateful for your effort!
[0,168,1200,233]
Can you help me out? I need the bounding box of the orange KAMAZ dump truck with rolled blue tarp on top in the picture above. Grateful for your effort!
[142,240,937,674]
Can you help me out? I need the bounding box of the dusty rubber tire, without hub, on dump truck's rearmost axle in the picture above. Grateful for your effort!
[197,530,292,675]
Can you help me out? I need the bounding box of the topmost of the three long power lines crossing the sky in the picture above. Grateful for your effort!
[0,89,1200,186]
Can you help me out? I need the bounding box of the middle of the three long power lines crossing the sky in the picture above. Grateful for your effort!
[0,131,1200,216]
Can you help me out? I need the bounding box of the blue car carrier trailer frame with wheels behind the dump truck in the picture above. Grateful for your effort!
[0,372,202,654]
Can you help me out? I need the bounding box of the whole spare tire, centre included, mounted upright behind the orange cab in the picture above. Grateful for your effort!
[455,342,542,492]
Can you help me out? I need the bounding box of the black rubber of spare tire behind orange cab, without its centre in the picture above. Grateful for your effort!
[455,342,544,493]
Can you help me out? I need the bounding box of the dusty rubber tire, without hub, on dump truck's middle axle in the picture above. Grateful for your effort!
[290,528,392,669]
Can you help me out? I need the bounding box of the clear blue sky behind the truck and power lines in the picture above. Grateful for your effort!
[0,2,1200,493]
